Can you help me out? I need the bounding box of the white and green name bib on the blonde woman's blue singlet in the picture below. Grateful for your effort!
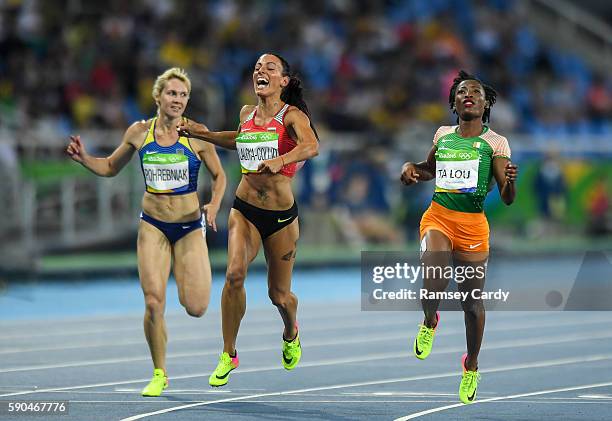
[142,153,189,192]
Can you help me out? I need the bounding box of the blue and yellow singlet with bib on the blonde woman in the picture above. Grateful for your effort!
[138,118,202,195]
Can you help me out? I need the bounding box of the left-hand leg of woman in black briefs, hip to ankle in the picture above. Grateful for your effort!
[221,209,261,355]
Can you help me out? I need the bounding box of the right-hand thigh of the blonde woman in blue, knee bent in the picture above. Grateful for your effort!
[172,228,212,304]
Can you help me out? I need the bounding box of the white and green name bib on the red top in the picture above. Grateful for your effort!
[236,132,278,173]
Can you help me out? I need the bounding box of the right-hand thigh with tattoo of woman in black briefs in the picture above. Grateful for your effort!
[264,218,300,292]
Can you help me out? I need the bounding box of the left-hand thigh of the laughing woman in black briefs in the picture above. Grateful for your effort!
[227,208,261,276]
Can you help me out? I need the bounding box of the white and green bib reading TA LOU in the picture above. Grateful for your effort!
[436,148,479,193]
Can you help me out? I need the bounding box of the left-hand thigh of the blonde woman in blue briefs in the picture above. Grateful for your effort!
[137,220,171,301]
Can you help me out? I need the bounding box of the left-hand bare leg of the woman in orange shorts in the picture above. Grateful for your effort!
[421,230,452,328]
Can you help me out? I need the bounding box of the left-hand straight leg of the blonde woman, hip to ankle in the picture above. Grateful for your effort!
[137,221,170,371]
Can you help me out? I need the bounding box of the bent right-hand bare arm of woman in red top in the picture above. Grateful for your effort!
[258,107,319,174]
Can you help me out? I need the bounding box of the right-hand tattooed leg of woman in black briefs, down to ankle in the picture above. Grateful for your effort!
[264,218,300,340]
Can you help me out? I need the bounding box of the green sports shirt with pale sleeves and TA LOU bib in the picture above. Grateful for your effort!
[432,126,510,213]
